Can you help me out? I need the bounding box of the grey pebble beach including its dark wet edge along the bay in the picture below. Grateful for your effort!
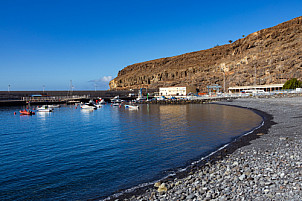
[110,97,302,201]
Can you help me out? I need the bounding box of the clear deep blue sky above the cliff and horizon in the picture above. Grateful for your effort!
[0,0,302,91]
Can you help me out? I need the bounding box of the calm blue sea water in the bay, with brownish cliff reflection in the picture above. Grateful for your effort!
[0,104,262,200]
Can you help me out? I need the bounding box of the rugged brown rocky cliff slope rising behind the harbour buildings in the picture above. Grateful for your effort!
[109,17,302,91]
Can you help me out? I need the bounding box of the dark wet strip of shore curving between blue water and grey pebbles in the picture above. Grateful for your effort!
[104,99,276,200]
